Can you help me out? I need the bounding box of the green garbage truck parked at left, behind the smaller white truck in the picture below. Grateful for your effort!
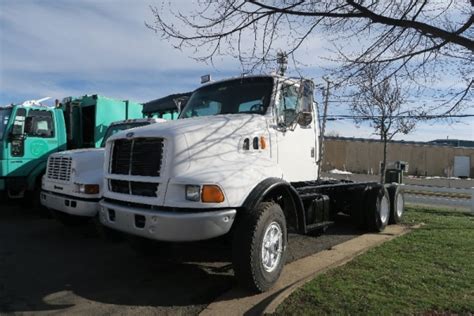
[0,94,143,206]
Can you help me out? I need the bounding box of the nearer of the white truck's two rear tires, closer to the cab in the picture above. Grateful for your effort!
[366,187,390,232]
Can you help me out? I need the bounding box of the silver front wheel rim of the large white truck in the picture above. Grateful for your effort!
[261,222,283,272]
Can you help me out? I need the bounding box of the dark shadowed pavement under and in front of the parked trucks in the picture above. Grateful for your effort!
[0,202,363,315]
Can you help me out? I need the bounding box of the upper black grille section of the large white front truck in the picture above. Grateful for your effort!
[110,138,163,177]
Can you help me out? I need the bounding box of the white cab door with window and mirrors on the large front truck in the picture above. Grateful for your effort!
[276,81,318,182]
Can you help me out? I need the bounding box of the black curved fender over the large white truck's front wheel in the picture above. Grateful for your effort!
[242,178,306,231]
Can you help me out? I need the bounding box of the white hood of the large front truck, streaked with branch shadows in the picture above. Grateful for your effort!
[108,114,272,177]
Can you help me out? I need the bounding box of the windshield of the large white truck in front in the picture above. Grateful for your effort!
[179,77,273,118]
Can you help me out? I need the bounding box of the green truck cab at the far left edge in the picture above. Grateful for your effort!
[0,105,66,197]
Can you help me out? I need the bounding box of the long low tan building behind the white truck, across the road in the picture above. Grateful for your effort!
[322,136,474,178]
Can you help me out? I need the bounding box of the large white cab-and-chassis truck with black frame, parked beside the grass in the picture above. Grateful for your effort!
[99,75,404,292]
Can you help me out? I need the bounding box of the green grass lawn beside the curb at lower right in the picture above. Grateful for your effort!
[276,208,474,315]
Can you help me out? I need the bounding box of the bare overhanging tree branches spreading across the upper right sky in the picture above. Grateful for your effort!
[146,0,474,113]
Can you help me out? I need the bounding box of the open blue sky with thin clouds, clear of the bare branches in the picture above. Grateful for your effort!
[0,0,474,141]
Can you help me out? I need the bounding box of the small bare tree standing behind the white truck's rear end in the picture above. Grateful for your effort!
[351,66,416,183]
